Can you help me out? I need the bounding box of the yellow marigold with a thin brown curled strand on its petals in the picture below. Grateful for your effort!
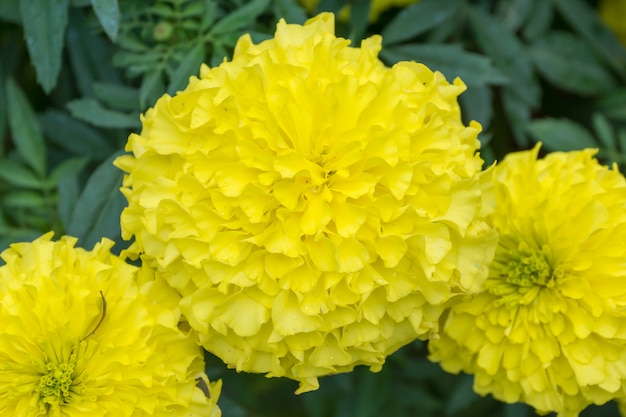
[0,234,220,417]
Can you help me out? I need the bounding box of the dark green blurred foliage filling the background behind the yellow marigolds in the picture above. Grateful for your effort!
[0,0,626,417]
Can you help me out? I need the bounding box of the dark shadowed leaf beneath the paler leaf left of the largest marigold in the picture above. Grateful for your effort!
[39,109,114,161]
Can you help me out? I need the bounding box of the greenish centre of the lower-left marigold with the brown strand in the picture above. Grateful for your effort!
[37,353,76,408]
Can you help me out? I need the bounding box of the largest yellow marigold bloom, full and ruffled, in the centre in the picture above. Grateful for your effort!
[116,13,495,392]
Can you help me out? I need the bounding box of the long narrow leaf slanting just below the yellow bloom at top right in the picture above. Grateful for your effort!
[553,0,626,79]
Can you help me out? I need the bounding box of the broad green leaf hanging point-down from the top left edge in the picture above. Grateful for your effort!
[20,0,69,93]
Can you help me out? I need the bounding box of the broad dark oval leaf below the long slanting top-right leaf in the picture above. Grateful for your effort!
[529,32,615,95]
